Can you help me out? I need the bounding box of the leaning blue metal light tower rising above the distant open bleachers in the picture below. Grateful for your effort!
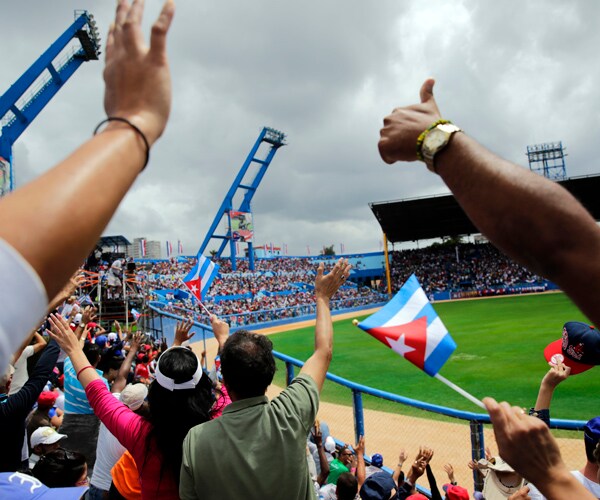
[198,127,285,271]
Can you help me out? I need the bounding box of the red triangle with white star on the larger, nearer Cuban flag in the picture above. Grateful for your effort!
[367,316,427,369]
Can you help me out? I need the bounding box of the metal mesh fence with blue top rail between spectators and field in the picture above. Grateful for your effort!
[147,306,586,494]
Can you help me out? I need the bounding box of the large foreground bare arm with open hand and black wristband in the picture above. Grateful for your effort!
[0,0,174,297]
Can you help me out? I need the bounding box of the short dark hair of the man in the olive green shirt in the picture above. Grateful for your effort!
[221,330,275,399]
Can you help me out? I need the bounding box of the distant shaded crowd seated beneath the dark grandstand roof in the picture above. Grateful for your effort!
[391,243,544,295]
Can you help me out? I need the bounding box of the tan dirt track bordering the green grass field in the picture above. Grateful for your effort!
[192,309,585,489]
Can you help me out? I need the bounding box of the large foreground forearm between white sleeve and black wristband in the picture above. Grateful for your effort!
[0,124,145,297]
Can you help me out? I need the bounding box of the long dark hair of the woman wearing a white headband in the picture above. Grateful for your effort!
[146,349,214,483]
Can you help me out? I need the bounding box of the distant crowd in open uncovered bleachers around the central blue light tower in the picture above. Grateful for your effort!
[145,257,387,326]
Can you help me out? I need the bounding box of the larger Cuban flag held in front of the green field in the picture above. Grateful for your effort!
[358,274,456,377]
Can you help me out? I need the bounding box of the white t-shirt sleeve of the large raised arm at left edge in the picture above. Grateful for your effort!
[0,238,48,373]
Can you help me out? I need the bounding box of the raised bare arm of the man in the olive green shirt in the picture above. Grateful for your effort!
[300,259,352,392]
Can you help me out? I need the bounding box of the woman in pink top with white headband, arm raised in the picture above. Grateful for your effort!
[50,314,221,499]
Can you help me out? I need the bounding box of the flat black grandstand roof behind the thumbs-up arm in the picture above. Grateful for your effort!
[369,175,600,243]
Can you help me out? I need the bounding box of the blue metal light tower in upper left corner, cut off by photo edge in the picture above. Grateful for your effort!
[0,11,100,196]
